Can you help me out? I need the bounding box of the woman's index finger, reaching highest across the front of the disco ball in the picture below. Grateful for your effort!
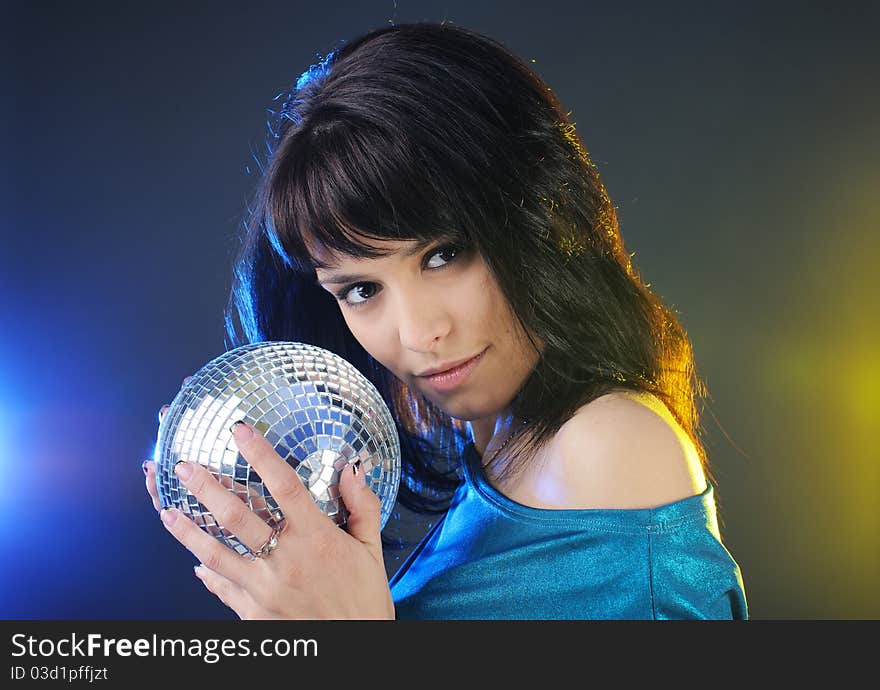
[232,422,326,534]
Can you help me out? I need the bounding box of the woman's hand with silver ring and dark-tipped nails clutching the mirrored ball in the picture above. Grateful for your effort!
[145,388,394,619]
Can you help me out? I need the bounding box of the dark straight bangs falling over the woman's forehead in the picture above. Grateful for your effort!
[267,113,472,273]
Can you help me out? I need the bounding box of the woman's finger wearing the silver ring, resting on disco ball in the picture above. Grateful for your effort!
[174,460,272,551]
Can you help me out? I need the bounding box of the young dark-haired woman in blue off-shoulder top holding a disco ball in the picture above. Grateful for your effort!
[145,23,747,619]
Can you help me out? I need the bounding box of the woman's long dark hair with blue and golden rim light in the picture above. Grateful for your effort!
[226,22,711,536]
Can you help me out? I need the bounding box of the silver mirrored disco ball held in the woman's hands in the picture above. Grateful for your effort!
[155,342,400,555]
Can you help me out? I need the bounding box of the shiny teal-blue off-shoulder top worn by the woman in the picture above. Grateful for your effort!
[389,442,748,620]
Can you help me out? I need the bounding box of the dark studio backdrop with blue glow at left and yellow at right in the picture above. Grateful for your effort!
[0,0,880,619]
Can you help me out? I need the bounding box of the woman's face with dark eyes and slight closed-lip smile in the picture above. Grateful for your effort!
[312,234,538,421]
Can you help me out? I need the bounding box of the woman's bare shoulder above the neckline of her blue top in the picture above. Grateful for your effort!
[511,391,706,509]
